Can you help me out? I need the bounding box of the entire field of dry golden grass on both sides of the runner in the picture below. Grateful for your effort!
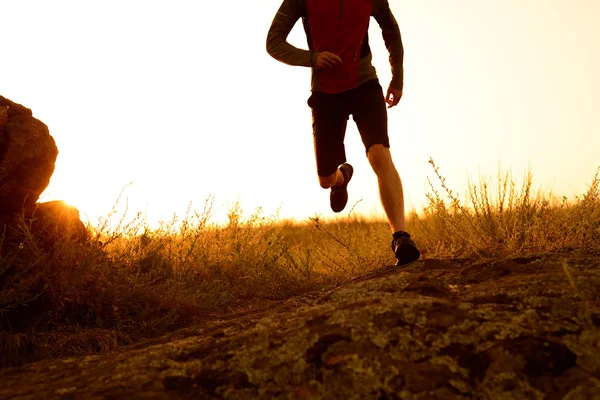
[0,160,600,366]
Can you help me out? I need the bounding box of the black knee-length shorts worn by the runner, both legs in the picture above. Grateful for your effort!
[308,79,390,176]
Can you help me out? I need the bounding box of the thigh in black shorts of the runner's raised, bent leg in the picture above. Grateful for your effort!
[308,92,350,176]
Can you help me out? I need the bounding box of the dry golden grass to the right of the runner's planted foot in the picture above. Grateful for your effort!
[409,160,600,258]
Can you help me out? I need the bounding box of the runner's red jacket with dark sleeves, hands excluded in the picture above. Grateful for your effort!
[267,0,404,93]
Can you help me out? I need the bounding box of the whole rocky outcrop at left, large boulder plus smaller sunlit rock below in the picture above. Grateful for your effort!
[0,96,87,248]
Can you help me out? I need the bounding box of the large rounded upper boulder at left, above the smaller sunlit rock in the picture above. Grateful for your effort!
[0,96,58,225]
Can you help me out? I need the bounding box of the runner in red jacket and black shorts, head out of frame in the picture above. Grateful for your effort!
[267,0,420,266]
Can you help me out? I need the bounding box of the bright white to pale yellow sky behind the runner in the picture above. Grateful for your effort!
[0,0,600,225]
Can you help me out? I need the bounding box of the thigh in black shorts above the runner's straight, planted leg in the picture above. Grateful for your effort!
[352,79,390,151]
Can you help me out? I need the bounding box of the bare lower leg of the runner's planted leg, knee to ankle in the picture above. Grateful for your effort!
[367,144,406,233]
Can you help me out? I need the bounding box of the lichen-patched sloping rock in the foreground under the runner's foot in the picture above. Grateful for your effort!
[0,256,600,400]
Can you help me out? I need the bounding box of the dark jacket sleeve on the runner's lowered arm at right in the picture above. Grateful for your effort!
[373,0,404,90]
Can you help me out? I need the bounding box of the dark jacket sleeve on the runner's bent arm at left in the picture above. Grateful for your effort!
[267,0,318,67]
